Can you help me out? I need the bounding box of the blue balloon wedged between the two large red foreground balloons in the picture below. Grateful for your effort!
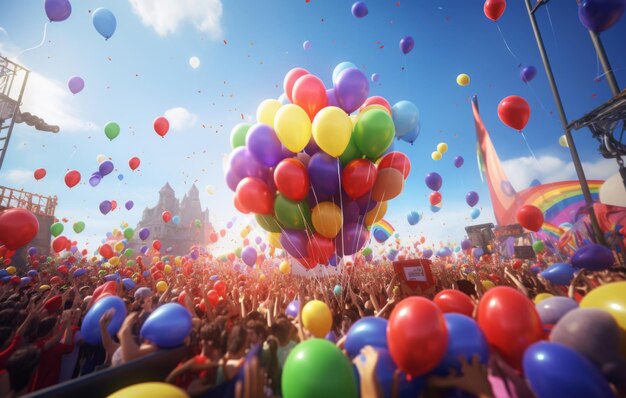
[435,314,489,376]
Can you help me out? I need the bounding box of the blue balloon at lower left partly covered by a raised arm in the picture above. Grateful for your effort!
[80,296,126,345]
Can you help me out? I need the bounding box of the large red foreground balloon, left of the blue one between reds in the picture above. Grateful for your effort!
[387,297,448,376]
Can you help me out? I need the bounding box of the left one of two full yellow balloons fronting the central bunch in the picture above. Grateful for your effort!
[274,104,311,153]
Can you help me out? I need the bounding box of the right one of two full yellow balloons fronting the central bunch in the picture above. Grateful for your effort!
[311,106,352,158]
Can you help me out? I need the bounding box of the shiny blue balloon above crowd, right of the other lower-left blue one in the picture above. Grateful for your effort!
[140,303,191,348]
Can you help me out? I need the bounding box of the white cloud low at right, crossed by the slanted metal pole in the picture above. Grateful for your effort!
[502,156,617,191]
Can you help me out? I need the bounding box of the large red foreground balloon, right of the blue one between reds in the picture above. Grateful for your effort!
[477,286,543,369]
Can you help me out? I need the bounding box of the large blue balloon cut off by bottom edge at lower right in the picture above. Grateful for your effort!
[523,342,615,398]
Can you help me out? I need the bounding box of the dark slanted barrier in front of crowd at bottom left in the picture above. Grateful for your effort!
[26,347,187,398]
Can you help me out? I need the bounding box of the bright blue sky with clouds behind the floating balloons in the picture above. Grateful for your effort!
[0,0,626,253]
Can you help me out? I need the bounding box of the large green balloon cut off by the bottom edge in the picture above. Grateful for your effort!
[281,339,358,398]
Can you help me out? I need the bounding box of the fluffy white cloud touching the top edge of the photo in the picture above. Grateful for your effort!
[129,0,222,39]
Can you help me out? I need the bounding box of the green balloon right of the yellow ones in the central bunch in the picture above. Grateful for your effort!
[352,109,395,160]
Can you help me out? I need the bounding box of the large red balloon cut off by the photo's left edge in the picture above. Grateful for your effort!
[0,208,39,249]
